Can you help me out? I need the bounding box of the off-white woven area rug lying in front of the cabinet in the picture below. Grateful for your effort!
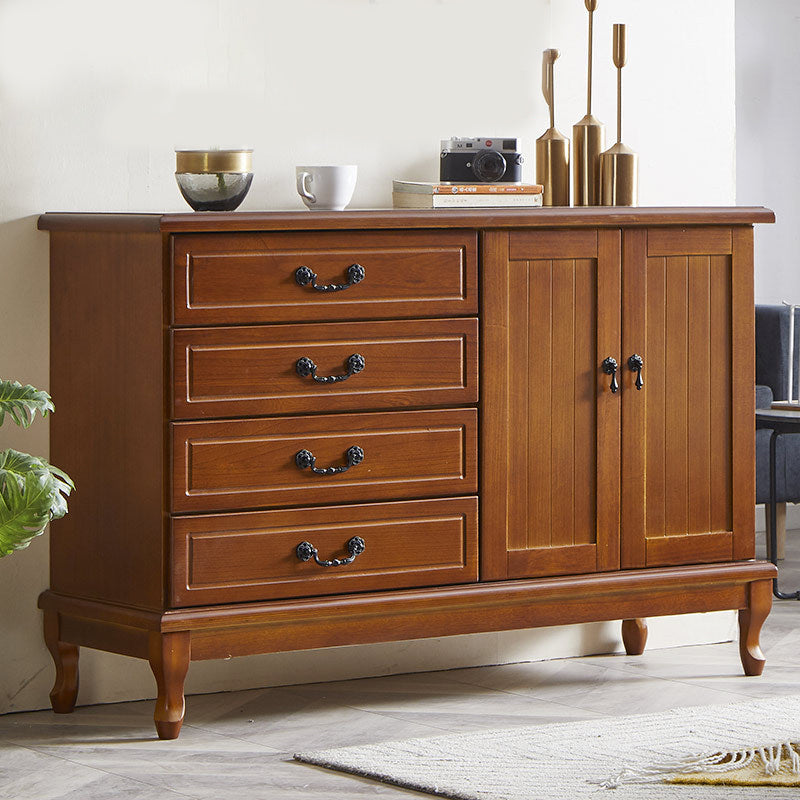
[295,695,800,800]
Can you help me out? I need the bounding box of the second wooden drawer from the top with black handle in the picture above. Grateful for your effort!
[173,319,478,419]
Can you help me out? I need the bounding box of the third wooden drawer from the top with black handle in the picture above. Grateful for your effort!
[172,408,478,512]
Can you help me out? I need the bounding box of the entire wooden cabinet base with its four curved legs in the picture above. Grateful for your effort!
[39,561,776,739]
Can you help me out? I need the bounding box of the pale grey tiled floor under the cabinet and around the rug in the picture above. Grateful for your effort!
[0,532,800,800]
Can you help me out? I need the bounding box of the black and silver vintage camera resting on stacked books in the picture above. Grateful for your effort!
[439,136,522,183]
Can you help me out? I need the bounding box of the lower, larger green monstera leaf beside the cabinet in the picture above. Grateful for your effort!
[0,450,75,557]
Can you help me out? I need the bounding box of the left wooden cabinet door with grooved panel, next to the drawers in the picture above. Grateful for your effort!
[481,230,621,580]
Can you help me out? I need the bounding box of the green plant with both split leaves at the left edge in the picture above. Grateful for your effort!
[0,379,75,558]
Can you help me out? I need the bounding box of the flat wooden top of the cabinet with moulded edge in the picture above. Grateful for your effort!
[39,206,775,233]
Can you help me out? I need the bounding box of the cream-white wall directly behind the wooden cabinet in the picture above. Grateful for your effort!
[0,0,734,712]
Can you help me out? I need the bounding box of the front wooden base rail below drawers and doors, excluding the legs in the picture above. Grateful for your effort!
[175,562,775,659]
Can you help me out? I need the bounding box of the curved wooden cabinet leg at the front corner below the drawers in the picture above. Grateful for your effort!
[149,631,191,739]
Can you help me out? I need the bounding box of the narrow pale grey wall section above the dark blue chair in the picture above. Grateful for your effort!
[736,0,800,303]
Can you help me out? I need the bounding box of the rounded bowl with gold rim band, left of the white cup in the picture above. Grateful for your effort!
[175,150,253,211]
